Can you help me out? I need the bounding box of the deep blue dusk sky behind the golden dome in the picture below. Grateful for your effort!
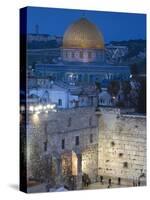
[27,7,146,43]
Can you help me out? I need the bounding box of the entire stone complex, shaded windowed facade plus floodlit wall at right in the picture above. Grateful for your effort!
[27,107,146,190]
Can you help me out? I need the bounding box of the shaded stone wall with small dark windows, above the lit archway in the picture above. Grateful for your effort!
[27,107,98,185]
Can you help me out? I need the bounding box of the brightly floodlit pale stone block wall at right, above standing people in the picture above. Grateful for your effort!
[98,108,146,183]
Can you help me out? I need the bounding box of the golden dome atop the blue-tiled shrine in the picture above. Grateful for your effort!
[63,18,104,49]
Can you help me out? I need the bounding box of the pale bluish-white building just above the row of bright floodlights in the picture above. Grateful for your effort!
[27,77,98,108]
